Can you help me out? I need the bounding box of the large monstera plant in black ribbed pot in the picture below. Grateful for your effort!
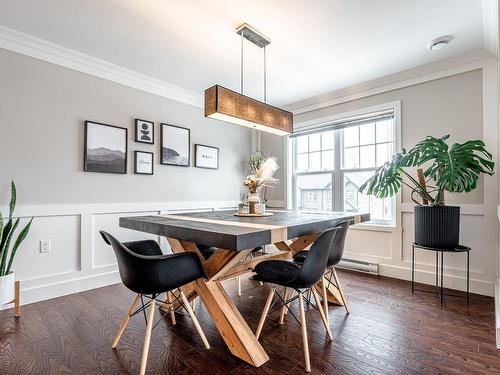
[359,135,495,249]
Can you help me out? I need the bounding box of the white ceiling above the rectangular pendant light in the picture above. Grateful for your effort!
[0,0,483,105]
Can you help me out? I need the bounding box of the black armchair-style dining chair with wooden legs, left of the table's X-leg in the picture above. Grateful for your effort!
[99,231,210,375]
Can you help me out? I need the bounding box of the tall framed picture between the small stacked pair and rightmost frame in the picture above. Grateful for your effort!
[160,124,191,167]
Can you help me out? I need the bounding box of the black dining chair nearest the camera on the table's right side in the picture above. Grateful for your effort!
[253,228,339,372]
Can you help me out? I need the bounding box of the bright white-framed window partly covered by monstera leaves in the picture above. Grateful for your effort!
[291,111,395,224]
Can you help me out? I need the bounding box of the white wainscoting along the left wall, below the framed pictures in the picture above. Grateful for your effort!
[0,201,238,309]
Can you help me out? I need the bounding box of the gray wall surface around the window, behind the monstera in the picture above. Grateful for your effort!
[262,70,486,204]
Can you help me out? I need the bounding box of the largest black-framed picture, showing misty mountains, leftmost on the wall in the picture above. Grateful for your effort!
[83,121,128,174]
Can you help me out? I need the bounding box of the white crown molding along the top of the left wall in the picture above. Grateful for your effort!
[0,25,203,108]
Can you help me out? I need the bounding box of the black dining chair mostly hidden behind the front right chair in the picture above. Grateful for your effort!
[293,219,352,320]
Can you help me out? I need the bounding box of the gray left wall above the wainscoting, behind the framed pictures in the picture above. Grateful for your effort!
[0,49,251,205]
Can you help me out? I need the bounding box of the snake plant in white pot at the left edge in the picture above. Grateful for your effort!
[0,181,33,305]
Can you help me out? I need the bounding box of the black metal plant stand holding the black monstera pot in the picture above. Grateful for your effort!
[411,243,471,306]
